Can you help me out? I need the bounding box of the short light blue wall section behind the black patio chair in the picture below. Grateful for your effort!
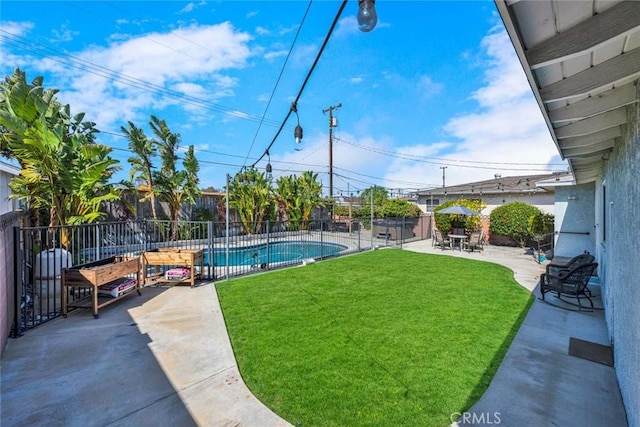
[554,183,596,257]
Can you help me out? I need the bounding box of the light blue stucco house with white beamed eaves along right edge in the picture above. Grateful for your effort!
[495,0,640,426]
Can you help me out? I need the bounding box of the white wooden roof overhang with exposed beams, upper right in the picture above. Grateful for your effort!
[494,0,640,184]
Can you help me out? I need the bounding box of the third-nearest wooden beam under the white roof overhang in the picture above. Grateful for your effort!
[549,83,640,123]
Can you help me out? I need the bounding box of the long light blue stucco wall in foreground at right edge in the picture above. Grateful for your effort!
[596,96,640,426]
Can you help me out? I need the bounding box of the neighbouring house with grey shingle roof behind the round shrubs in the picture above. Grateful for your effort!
[413,173,570,215]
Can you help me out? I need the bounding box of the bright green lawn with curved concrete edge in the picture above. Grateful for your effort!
[216,249,533,426]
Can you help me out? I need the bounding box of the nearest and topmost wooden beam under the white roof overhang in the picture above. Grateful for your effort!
[526,1,640,69]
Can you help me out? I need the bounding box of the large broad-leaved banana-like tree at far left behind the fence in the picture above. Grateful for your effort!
[0,69,119,231]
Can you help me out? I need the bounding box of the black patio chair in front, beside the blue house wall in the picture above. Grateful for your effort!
[540,262,598,311]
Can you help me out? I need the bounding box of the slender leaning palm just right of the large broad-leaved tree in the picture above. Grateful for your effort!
[120,122,158,220]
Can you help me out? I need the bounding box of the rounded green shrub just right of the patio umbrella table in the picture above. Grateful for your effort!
[489,202,541,247]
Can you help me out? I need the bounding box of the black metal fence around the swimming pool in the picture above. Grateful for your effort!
[11,218,430,337]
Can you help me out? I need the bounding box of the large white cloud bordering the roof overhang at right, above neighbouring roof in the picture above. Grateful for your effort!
[385,23,566,187]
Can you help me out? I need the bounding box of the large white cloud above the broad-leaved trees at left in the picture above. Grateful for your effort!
[23,22,253,129]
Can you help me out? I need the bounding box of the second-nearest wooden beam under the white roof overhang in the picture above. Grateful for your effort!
[540,48,640,102]
